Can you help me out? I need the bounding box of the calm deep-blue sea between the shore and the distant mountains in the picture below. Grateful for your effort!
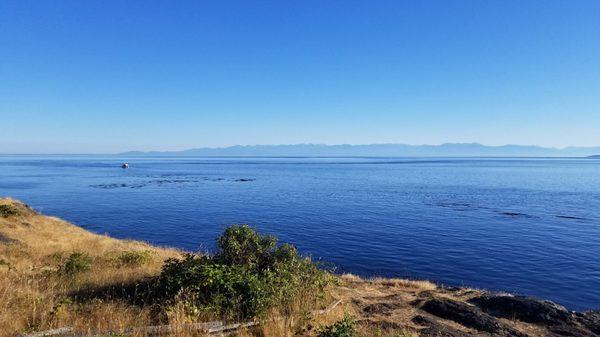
[0,156,600,310]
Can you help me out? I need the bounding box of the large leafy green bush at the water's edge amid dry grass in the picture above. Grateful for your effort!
[157,225,331,319]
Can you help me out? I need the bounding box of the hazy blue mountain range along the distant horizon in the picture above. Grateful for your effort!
[120,143,600,157]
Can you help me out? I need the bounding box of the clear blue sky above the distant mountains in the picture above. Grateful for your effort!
[0,0,600,153]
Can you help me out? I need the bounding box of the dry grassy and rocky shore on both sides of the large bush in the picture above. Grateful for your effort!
[0,199,600,337]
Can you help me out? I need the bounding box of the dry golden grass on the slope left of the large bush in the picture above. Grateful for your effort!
[0,199,180,336]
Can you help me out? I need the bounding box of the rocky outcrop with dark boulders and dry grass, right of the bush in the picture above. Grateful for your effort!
[340,277,600,337]
